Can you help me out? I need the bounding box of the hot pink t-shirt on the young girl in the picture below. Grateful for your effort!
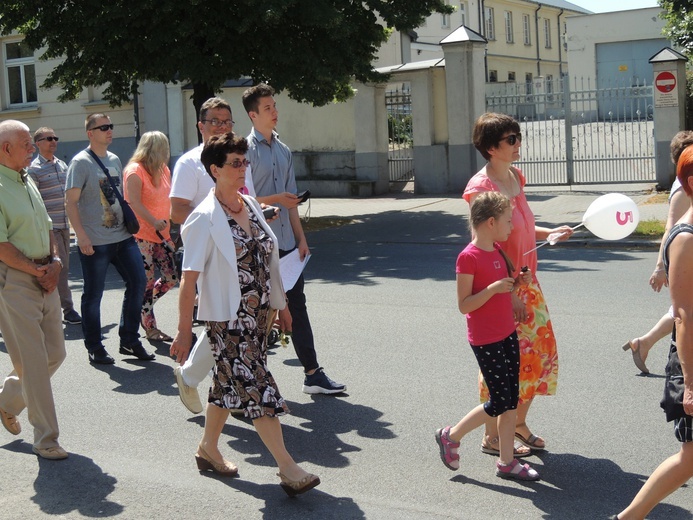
[455,244,515,346]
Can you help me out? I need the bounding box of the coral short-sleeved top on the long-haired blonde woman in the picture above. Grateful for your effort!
[123,163,171,243]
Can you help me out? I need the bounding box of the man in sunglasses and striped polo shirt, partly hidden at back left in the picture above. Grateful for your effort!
[27,126,82,324]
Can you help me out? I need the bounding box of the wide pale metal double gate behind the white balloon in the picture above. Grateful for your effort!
[486,76,656,185]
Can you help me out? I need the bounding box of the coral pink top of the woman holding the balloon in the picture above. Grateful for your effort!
[462,168,537,276]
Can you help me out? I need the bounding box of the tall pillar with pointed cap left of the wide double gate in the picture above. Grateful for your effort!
[444,26,486,193]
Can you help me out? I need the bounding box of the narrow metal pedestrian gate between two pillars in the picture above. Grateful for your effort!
[385,84,414,182]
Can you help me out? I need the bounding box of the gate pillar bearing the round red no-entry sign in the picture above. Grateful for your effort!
[650,47,688,188]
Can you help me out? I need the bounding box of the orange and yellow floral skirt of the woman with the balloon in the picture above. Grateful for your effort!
[479,277,558,404]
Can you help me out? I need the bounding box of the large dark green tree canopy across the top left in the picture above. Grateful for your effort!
[0,0,452,108]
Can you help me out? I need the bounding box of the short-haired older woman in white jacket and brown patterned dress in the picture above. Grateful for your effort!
[171,133,320,496]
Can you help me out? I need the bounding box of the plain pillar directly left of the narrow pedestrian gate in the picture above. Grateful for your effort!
[354,83,389,195]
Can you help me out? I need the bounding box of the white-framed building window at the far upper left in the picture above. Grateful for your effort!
[3,41,38,107]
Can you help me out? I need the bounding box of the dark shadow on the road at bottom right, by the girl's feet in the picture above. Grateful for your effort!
[451,452,693,520]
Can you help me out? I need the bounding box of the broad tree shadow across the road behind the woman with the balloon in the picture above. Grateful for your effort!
[306,211,648,287]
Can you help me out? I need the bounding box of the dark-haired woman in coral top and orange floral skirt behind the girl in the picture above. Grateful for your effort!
[462,113,573,457]
